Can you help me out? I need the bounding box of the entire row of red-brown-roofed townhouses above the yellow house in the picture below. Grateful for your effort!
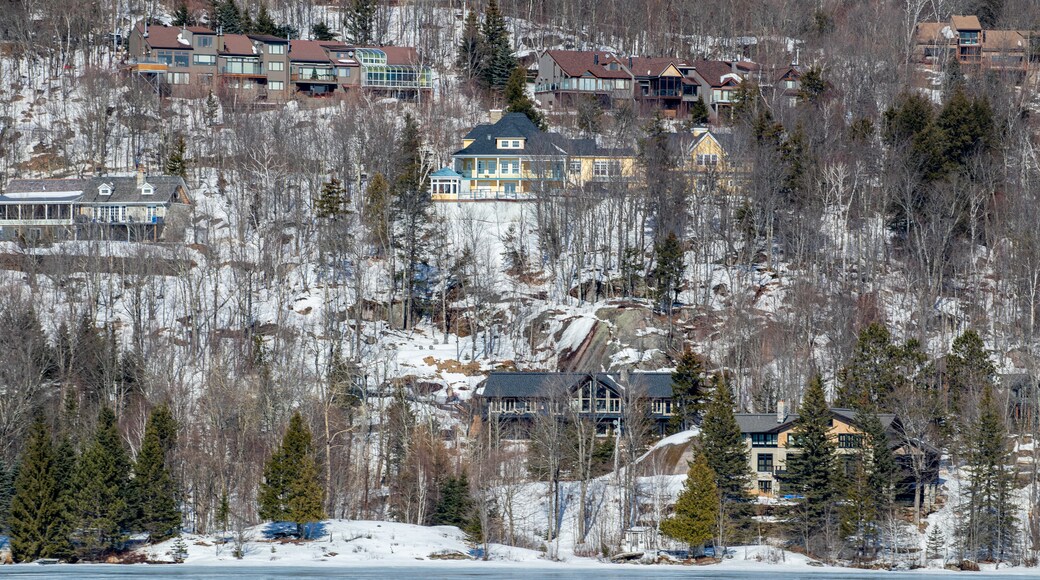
[535,50,759,117]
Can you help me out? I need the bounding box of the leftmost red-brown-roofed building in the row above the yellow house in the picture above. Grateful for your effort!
[535,50,634,109]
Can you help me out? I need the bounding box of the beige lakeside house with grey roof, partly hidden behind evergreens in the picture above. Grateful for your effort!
[736,401,939,505]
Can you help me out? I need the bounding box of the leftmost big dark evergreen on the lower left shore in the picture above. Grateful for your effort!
[10,417,68,561]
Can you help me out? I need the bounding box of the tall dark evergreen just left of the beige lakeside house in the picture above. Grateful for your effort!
[701,373,751,547]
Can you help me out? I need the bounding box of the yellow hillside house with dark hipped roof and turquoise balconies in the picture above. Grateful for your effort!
[430,112,635,202]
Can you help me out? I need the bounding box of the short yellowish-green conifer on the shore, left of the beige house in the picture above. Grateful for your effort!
[660,450,719,548]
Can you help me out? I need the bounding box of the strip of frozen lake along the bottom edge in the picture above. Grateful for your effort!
[0,562,1024,580]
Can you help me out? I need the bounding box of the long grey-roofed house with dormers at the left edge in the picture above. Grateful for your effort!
[0,172,191,244]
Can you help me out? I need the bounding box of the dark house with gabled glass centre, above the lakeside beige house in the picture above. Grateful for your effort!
[477,371,673,439]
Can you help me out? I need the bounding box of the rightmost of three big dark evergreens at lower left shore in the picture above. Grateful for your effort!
[131,404,181,542]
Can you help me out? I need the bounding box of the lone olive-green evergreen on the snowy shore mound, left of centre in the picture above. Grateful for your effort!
[257,412,324,537]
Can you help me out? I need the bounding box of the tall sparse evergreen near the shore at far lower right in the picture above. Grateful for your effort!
[959,385,1018,561]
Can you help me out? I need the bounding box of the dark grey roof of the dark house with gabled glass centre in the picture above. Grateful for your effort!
[480,372,672,399]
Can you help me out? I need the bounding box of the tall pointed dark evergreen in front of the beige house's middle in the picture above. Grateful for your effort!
[783,374,837,551]
